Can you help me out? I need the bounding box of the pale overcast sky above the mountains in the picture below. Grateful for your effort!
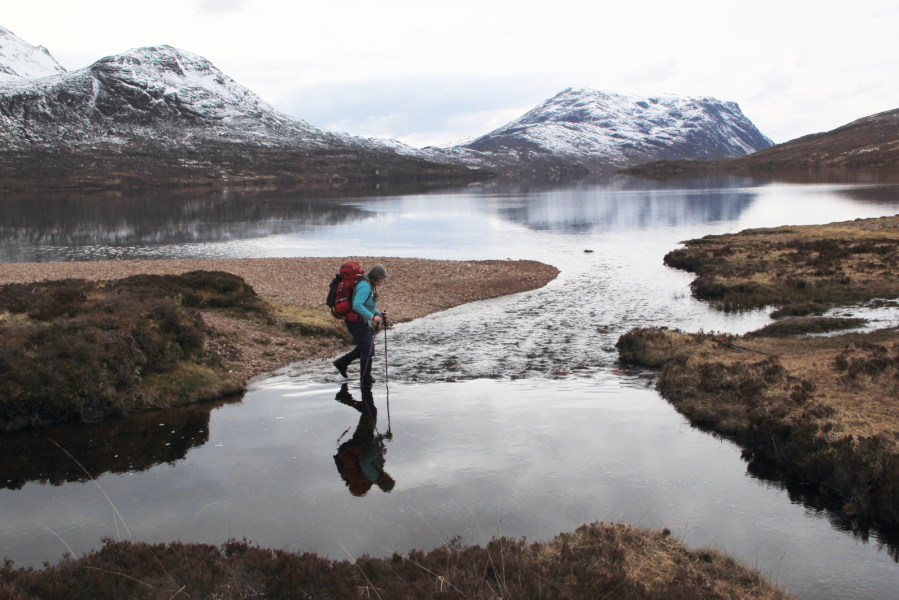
[0,0,899,146]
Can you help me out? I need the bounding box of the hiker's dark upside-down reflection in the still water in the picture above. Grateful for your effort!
[334,384,396,496]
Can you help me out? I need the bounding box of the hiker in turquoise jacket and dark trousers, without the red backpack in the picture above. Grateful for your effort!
[334,265,387,389]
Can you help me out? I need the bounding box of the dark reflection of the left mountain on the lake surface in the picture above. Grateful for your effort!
[0,192,370,262]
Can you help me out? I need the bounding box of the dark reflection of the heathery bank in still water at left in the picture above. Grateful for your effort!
[0,397,240,490]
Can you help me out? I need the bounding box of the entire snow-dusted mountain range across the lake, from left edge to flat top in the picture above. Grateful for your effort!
[0,29,771,186]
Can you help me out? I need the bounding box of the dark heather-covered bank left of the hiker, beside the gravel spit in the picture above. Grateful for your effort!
[0,272,256,431]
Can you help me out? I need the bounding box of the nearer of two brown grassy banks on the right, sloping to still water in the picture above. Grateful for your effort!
[619,329,899,526]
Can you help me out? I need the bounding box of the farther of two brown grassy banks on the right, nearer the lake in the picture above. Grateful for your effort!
[664,216,899,317]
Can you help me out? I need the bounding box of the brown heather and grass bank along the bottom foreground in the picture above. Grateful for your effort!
[0,523,788,600]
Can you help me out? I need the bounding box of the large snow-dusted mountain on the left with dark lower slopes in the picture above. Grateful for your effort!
[0,31,473,189]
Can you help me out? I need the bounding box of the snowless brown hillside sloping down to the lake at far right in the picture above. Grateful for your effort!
[623,109,899,177]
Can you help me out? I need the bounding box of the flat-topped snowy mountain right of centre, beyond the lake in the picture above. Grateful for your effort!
[462,88,773,169]
